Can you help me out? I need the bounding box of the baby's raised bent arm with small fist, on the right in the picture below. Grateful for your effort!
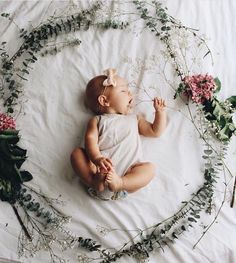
[138,98,166,137]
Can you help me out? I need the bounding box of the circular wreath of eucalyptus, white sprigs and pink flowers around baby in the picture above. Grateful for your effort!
[0,1,236,262]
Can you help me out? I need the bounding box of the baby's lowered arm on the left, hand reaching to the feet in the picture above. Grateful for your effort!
[85,117,112,171]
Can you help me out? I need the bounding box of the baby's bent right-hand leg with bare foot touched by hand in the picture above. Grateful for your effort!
[106,162,155,193]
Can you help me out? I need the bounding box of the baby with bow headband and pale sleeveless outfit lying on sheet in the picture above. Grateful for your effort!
[71,69,166,199]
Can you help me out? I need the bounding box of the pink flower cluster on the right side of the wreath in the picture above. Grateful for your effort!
[183,74,216,104]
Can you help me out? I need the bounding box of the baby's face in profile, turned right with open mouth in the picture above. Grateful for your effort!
[107,76,133,115]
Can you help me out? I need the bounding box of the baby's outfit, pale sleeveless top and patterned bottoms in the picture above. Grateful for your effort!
[90,114,142,200]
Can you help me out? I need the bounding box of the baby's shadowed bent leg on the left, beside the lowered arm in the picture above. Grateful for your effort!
[71,148,105,192]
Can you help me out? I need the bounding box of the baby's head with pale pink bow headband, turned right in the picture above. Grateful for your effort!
[85,69,132,114]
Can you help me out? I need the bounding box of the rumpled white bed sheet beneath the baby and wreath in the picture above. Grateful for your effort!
[0,0,236,263]
